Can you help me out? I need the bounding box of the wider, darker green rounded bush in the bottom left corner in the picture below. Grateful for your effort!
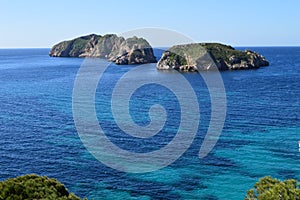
[0,174,80,200]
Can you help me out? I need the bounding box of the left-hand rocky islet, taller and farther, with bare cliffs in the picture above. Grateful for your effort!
[49,34,156,65]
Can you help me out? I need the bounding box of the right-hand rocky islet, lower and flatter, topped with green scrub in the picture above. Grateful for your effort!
[157,43,269,72]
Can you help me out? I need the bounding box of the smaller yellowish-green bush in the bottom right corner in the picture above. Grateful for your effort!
[245,176,300,200]
